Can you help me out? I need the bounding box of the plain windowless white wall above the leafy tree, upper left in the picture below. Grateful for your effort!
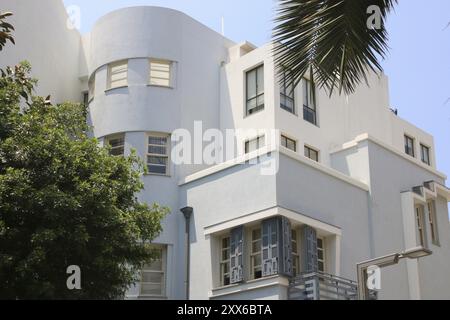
[0,0,82,103]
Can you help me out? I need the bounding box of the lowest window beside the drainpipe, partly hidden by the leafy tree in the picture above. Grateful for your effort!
[140,247,167,297]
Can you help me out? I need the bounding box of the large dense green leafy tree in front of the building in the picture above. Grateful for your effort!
[0,64,168,299]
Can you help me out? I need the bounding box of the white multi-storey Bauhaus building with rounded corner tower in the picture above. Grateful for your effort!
[0,0,450,300]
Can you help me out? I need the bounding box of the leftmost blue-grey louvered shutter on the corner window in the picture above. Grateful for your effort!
[230,227,244,283]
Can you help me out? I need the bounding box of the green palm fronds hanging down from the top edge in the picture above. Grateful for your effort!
[273,0,397,95]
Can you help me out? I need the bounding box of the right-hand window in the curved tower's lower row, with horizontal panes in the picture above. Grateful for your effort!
[147,135,169,175]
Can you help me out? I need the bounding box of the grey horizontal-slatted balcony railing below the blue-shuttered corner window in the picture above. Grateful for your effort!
[288,272,377,300]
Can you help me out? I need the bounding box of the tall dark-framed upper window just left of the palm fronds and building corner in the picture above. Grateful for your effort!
[246,65,264,115]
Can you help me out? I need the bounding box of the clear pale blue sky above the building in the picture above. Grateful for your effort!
[64,0,450,180]
